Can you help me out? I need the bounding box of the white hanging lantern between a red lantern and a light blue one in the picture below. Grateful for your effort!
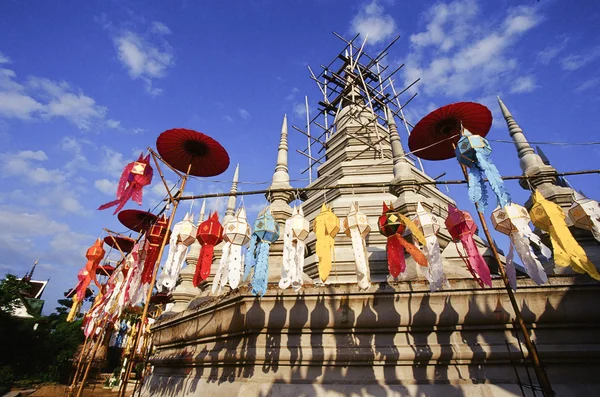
[212,207,252,294]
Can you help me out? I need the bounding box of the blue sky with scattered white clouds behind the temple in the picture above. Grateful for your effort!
[0,0,600,312]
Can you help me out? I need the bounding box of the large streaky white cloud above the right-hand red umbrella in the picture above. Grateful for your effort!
[403,0,543,97]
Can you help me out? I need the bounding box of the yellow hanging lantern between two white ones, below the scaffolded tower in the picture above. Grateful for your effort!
[313,204,340,282]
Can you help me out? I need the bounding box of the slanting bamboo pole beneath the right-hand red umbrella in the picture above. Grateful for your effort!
[459,159,555,397]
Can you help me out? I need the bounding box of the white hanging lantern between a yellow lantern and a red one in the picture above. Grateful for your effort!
[343,202,371,289]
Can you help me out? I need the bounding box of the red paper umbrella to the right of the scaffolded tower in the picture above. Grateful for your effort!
[408,102,492,160]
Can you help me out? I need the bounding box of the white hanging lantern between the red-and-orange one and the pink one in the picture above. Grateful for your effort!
[413,202,447,292]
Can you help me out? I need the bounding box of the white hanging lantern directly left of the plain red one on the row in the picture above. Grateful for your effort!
[158,213,198,291]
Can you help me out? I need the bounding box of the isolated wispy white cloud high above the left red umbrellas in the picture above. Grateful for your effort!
[109,21,175,96]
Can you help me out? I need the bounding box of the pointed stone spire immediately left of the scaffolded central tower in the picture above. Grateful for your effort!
[266,115,293,223]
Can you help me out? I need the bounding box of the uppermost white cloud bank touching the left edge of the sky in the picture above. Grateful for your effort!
[0,58,115,130]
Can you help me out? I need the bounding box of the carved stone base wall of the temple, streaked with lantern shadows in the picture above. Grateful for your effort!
[142,276,600,397]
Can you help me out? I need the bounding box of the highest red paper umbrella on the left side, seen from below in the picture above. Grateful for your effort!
[156,128,229,176]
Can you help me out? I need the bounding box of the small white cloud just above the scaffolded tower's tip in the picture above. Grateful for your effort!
[350,0,396,44]
